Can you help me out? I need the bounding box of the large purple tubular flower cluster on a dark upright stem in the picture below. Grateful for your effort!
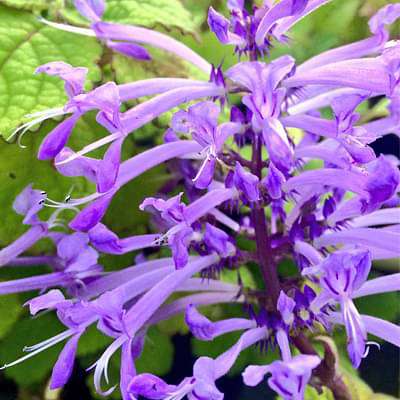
[0,0,400,400]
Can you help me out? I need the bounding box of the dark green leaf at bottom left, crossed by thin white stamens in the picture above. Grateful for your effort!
[0,314,65,387]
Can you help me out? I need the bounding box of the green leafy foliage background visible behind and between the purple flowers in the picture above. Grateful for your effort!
[0,0,400,400]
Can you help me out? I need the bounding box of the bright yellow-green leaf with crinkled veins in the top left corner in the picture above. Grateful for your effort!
[0,6,101,138]
